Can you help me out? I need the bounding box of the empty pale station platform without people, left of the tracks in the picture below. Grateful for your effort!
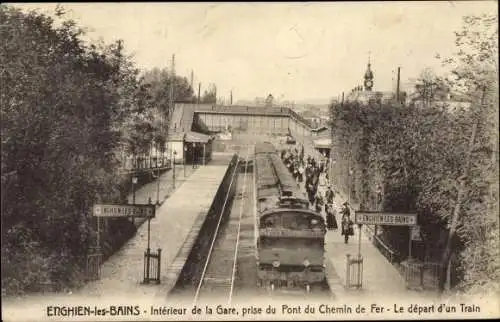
[74,156,230,299]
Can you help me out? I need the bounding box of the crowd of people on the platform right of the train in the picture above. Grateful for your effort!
[281,146,354,244]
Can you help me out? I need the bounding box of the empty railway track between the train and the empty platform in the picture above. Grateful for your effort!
[194,148,250,304]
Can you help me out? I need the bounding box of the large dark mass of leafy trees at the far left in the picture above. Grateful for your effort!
[0,5,142,293]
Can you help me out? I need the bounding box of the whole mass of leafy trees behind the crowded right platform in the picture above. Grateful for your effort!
[331,16,500,294]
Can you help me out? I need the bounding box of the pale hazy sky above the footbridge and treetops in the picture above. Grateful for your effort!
[16,1,497,101]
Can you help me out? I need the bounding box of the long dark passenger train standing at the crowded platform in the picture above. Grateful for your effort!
[253,142,327,293]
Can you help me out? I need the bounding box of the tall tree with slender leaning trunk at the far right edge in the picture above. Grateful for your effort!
[440,14,500,294]
